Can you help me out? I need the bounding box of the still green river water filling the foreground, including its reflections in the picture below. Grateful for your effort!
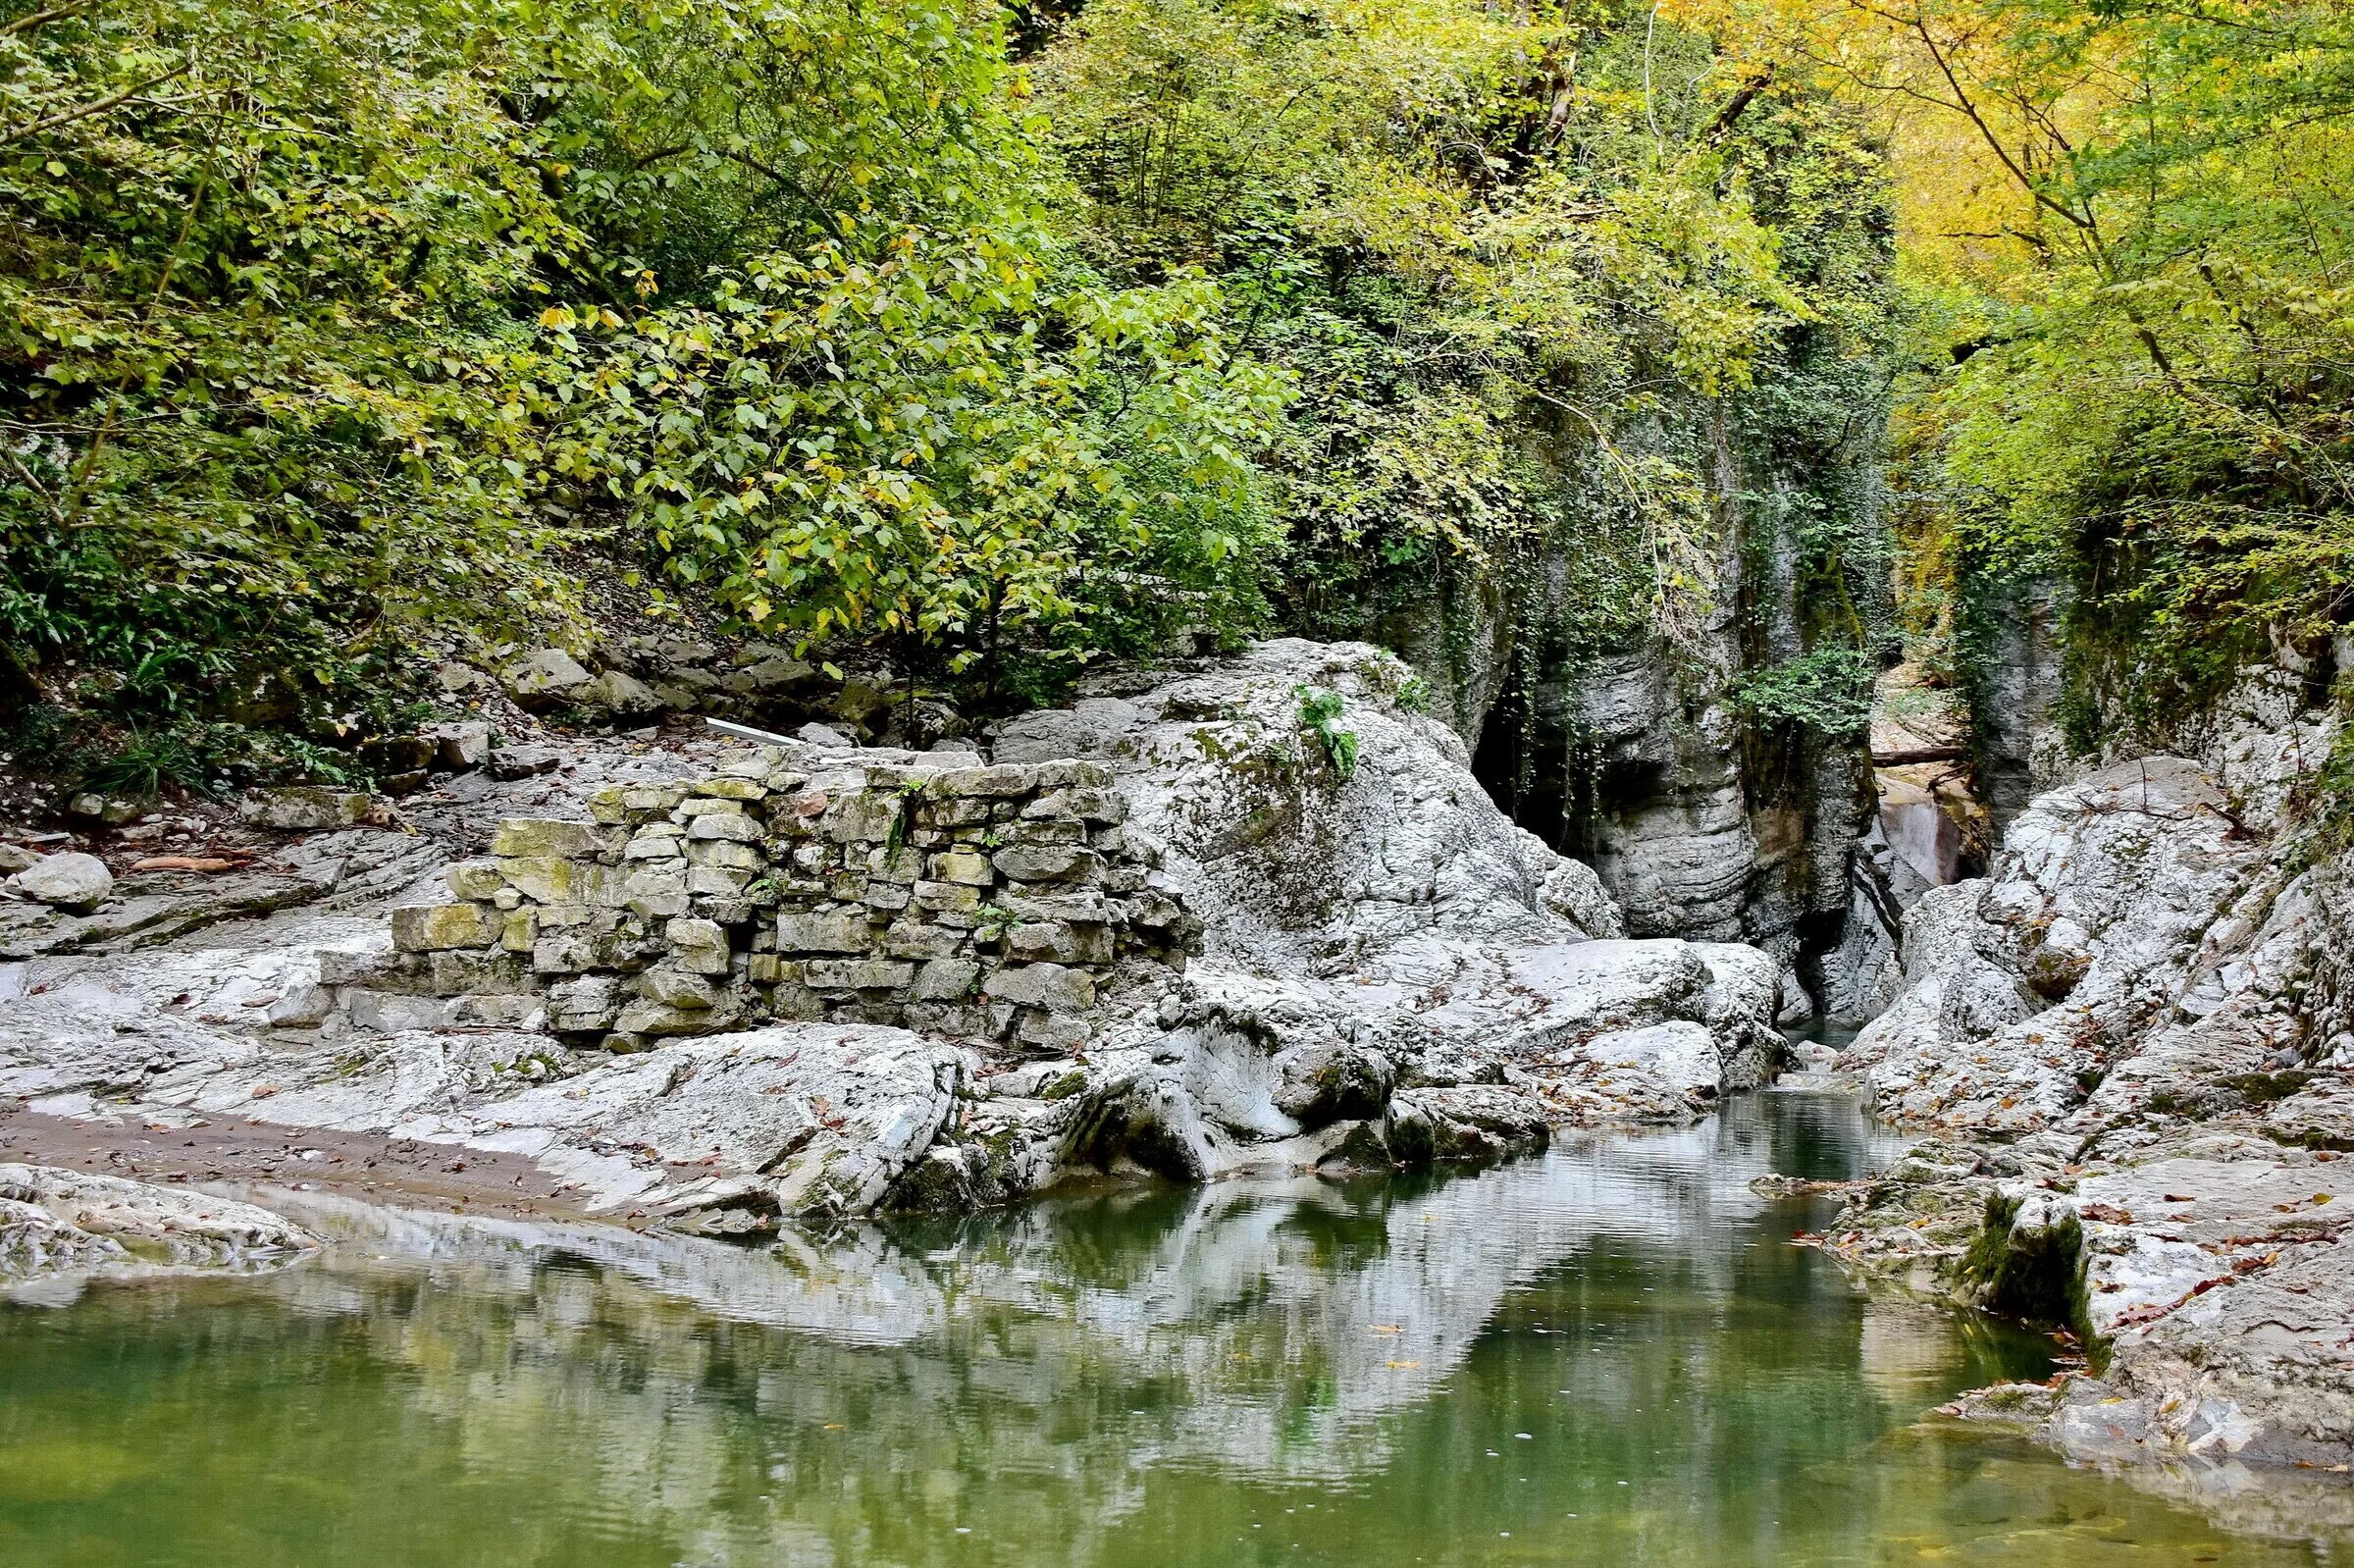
[0,1095,2354,1568]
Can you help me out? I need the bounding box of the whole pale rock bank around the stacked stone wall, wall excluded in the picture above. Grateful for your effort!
[0,643,1780,1231]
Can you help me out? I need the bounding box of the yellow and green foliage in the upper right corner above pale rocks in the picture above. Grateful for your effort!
[1845,2,2354,742]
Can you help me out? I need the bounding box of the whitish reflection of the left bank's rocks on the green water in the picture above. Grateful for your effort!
[234,1097,1954,1479]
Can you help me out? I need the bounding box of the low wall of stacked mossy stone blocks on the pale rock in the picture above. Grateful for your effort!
[320,749,1200,1050]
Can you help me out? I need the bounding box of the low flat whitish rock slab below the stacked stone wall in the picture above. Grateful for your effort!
[0,965,977,1231]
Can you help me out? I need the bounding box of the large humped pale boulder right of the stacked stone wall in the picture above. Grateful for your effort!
[996,641,1780,1171]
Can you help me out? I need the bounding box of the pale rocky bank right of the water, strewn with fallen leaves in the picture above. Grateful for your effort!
[1841,697,2354,1478]
